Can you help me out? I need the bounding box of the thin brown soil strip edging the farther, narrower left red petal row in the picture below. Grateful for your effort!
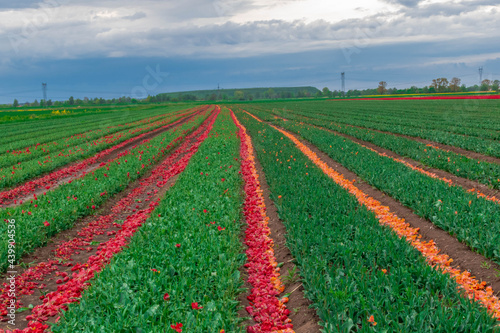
[0,105,205,208]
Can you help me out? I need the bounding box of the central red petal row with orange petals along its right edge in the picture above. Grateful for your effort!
[231,111,294,333]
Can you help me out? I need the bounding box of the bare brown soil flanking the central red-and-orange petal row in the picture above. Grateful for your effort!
[239,144,320,333]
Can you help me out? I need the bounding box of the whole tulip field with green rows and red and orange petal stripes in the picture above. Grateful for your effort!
[0,99,500,333]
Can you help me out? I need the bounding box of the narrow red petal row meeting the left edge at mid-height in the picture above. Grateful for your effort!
[0,108,207,207]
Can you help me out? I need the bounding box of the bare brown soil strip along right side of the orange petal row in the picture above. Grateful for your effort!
[283,129,500,296]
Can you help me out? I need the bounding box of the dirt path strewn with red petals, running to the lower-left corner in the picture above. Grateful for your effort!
[0,109,219,331]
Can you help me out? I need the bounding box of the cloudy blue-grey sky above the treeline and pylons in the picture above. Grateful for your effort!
[0,0,500,103]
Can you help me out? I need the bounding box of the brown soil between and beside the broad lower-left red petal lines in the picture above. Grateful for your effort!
[0,109,212,330]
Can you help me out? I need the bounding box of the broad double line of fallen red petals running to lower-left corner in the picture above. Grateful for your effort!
[0,108,220,333]
